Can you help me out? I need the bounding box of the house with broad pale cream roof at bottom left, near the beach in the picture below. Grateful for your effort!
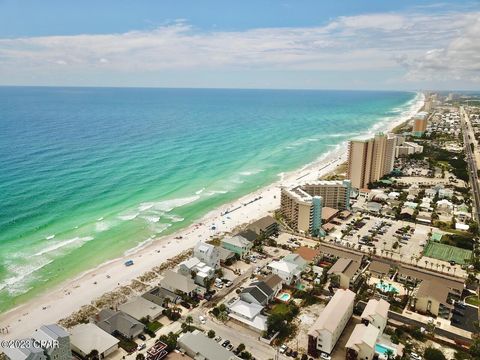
[70,323,120,359]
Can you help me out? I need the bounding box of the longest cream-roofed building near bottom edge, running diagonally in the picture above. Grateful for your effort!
[308,289,355,357]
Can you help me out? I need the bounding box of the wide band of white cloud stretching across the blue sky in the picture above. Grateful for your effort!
[0,12,480,86]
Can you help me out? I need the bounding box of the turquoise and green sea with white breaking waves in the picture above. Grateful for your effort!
[0,87,418,310]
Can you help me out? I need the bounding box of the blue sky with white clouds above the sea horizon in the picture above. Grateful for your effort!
[0,0,480,90]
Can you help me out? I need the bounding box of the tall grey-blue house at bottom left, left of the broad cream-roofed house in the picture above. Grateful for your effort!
[32,324,72,360]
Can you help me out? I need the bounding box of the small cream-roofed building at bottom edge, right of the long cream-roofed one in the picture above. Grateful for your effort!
[345,324,380,360]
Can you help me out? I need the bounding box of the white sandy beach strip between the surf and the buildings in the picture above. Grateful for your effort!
[0,93,424,338]
